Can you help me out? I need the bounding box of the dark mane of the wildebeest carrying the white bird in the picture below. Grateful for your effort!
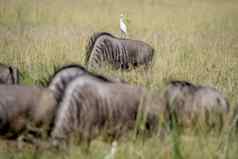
[85,32,113,65]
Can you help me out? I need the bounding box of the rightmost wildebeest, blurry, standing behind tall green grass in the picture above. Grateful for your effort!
[165,81,229,127]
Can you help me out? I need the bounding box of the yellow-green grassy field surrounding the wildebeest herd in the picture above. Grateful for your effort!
[0,0,238,159]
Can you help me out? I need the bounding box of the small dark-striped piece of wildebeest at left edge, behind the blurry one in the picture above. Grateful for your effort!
[0,63,19,84]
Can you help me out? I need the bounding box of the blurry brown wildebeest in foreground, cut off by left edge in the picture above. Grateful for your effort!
[0,85,56,138]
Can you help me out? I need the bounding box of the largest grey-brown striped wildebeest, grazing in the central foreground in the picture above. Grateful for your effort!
[51,74,164,148]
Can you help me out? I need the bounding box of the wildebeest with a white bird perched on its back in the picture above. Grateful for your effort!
[85,32,154,69]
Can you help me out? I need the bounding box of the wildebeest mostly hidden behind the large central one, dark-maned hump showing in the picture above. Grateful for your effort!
[47,64,126,103]
